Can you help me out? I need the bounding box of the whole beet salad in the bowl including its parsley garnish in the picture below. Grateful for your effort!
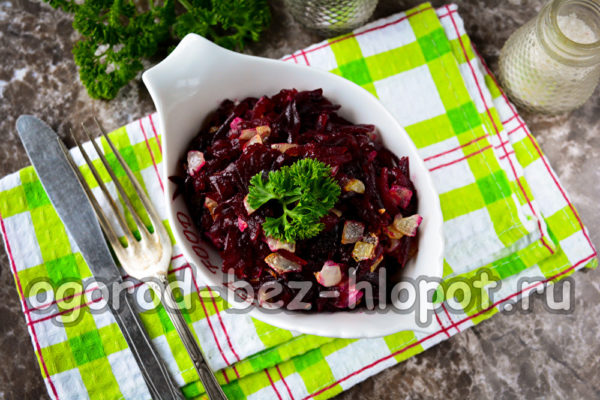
[181,89,422,312]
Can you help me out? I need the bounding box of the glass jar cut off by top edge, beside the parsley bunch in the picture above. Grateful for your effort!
[285,0,378,36]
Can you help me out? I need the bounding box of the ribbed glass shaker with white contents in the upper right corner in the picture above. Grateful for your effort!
[500,0,600,113]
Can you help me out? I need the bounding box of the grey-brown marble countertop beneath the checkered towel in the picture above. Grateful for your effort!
[0,0,600,400]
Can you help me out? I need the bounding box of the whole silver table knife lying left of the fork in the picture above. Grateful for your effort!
[17,115,184,399]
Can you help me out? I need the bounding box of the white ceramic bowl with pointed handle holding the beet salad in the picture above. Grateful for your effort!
[143,34,444,338]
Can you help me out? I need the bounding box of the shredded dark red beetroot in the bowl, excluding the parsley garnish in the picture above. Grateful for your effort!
[178,89,418,312]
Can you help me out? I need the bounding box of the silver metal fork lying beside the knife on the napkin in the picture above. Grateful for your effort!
[63,121,227,400]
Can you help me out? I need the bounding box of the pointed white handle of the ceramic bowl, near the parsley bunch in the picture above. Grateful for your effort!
[142,33,240,115]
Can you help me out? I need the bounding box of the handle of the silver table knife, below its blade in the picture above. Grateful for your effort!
[109,293,185,400]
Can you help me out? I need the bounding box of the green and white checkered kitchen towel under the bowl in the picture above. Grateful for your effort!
[0,4,597,399]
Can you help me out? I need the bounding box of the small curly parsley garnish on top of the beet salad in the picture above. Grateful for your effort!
[248,158,341,243]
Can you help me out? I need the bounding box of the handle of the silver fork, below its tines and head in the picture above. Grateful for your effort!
[157,275,227,400]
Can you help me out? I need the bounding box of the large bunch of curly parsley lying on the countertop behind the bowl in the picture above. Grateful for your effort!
[44,0,271,100]
